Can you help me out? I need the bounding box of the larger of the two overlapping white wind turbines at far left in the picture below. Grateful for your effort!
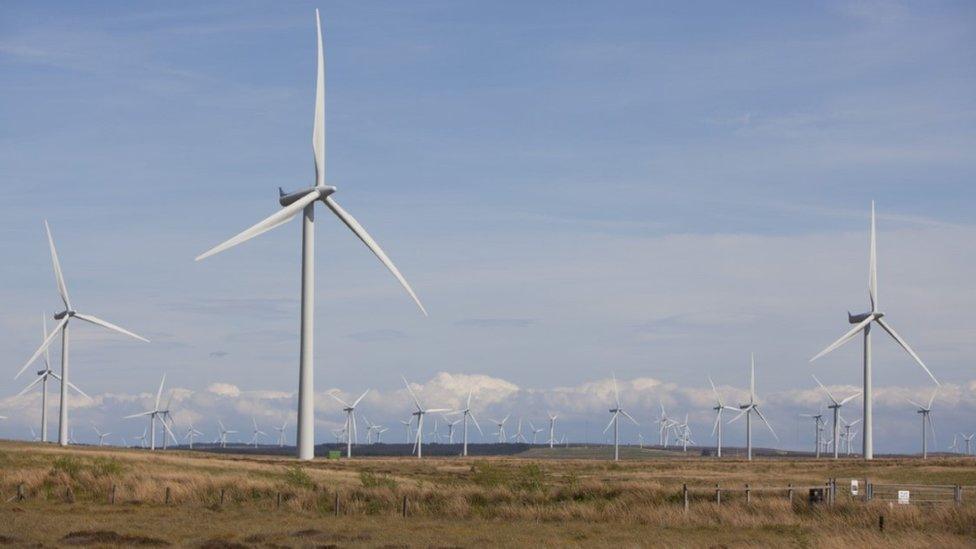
[14,221,149,446]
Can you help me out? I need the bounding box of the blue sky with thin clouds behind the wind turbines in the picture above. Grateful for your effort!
[0,1,976,451]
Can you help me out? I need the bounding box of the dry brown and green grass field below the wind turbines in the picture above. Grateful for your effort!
[0,442,976,547]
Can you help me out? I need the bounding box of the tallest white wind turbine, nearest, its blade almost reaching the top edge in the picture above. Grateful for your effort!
[196,10,427,460]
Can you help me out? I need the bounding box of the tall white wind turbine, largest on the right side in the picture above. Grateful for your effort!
[810,200,940,459]
